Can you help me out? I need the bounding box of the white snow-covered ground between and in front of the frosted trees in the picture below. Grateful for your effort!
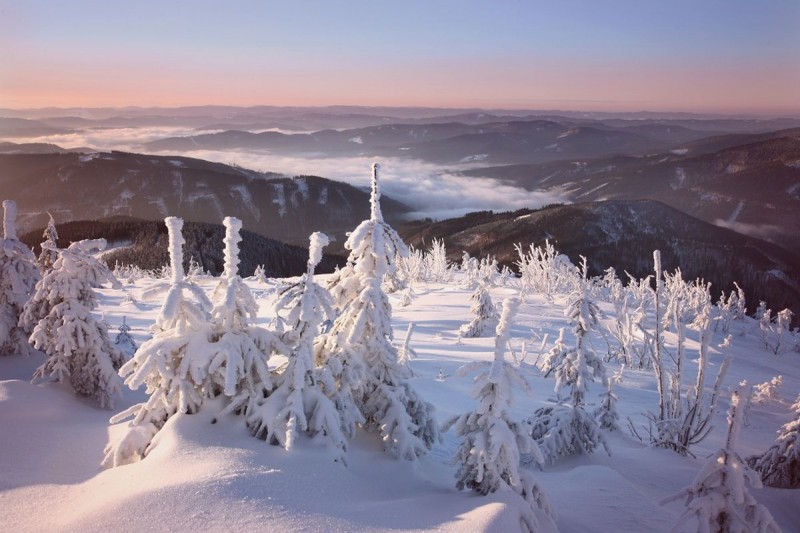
[0,276,800,533]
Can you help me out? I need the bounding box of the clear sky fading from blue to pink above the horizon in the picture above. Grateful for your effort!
[0,0,800,115]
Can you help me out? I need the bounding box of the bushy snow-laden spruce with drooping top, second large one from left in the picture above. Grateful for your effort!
[20,239,125,409]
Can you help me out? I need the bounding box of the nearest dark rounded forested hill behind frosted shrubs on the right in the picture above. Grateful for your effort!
[399,200,800,315]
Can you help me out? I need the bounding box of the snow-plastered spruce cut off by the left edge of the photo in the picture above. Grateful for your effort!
[0,200,41,356]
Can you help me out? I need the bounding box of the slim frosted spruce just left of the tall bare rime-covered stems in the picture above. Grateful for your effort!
[532,290,610,462]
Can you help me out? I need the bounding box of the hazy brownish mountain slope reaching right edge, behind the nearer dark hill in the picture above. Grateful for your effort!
[462,128,800,252]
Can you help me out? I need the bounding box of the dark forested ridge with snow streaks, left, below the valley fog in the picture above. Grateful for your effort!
[0,152,409,250]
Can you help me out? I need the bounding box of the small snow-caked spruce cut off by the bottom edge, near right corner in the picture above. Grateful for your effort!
[661,383,780,533]
